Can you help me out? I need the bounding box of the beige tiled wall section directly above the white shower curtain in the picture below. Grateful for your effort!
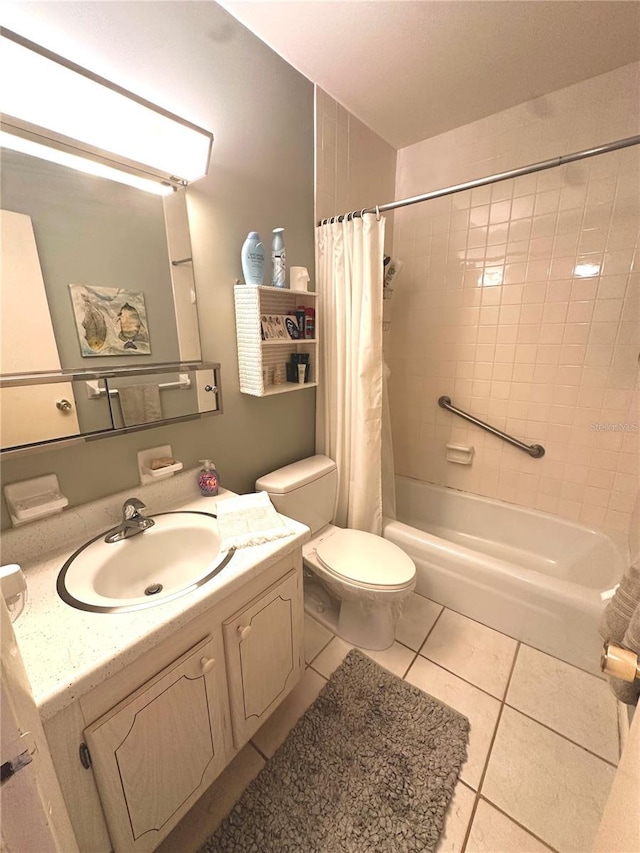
[316,86,396,251]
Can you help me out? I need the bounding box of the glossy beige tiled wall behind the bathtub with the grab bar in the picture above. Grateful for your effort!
[388,63,640,533]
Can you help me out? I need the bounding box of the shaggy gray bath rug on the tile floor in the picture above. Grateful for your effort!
[200,649,469,853]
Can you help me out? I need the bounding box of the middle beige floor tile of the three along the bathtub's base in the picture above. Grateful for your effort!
[420,610,518,699]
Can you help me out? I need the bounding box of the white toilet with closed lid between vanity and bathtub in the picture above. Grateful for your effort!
[256,456,416,649]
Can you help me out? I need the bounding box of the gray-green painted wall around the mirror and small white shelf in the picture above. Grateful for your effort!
[2,2,315,527]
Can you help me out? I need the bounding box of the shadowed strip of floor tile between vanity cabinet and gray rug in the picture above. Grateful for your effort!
[156,744,265,853]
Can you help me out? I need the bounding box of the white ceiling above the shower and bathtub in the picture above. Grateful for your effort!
[220,0,640,148]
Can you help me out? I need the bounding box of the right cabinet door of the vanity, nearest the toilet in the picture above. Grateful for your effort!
[223,571,304,749]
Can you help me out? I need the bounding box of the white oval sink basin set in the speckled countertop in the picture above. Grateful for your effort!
[57,512,234,613]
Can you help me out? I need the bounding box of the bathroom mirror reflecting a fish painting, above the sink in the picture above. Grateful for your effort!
[0,149,208,449]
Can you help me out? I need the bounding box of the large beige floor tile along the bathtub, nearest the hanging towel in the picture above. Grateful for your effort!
[506,646,620,763]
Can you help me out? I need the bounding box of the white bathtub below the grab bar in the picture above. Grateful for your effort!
[384,477,625,675]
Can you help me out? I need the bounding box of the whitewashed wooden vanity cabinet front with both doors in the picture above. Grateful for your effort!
[44,547,304,853]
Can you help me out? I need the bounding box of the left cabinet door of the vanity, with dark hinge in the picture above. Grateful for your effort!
[85,636,227,853]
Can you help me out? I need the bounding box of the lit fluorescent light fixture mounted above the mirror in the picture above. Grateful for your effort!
[0,28,213,185]
